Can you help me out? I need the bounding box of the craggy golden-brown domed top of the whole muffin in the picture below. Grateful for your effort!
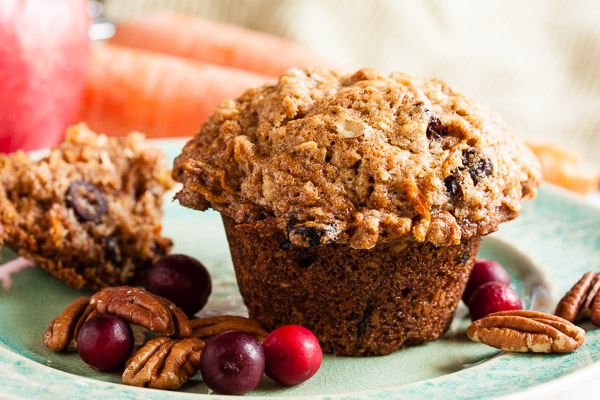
[173,68,540,249]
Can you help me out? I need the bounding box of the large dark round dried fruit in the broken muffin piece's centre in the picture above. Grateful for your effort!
[67,180,107,222]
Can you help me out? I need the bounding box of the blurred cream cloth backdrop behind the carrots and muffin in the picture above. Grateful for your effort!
[105,0,600,168]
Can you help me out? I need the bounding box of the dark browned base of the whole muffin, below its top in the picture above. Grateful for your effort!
[223,217,481,356]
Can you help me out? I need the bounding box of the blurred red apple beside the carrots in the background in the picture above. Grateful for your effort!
[0,0,90,152]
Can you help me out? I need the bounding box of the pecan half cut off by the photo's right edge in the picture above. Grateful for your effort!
[554,271,600,325]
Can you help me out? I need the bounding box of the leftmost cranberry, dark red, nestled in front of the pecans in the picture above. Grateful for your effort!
[77,314,133,372]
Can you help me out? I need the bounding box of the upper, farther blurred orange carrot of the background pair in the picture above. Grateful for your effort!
[110,14,334,76]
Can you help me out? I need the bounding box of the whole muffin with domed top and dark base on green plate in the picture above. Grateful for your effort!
[173,68,540,356]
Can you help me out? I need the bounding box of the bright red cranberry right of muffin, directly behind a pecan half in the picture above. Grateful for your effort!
[469,282,523,321]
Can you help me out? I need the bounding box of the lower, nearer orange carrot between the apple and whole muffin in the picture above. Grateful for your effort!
[72,45,274,137]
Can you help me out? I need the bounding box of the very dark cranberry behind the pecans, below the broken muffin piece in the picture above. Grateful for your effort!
[145,254,212,316]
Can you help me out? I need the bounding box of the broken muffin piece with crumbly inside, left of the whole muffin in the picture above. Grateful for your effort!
[0,125,173,289]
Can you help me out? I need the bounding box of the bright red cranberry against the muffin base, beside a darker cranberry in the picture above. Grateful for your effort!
[263,325,323,386]
